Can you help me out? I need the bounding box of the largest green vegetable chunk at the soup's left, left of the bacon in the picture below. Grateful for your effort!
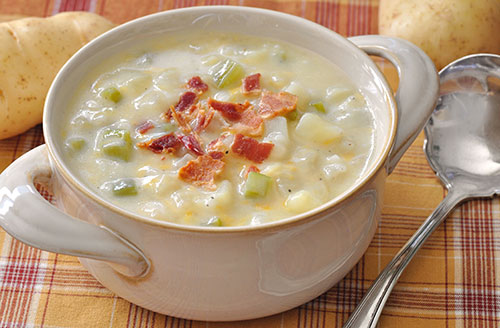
[101,129,132,162]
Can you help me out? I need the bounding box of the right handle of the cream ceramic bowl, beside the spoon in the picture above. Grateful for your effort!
[349,35,439,173]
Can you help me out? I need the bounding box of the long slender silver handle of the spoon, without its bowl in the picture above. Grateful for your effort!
[343,189,466,328]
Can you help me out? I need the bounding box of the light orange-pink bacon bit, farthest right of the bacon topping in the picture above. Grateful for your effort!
[258,91,297,119]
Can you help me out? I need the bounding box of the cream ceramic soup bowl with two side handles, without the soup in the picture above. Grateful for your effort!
[0,6,438,321]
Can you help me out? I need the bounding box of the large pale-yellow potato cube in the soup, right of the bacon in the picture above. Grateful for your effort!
[295,113,342,144]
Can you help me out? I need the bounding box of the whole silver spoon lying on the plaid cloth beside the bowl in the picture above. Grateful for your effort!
[343,54,500,328]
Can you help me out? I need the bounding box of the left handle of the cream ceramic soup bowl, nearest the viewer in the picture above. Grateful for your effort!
[0,145,150,277]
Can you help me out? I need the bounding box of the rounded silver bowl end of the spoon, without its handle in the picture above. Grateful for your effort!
[424,54,500,197]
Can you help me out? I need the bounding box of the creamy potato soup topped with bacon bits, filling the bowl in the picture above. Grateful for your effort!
[62,32,375,226]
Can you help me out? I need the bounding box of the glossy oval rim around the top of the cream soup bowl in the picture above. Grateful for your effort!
[43,6,398,234]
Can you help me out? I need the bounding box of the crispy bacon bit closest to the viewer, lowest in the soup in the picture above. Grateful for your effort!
[179,155,225,190]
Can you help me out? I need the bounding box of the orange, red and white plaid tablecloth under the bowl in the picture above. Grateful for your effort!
[0,0,500,328]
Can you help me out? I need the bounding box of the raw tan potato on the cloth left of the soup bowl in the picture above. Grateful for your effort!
[0,12,114,139]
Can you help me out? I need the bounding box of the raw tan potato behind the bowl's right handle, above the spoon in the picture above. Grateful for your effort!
[379,0,500,69]
